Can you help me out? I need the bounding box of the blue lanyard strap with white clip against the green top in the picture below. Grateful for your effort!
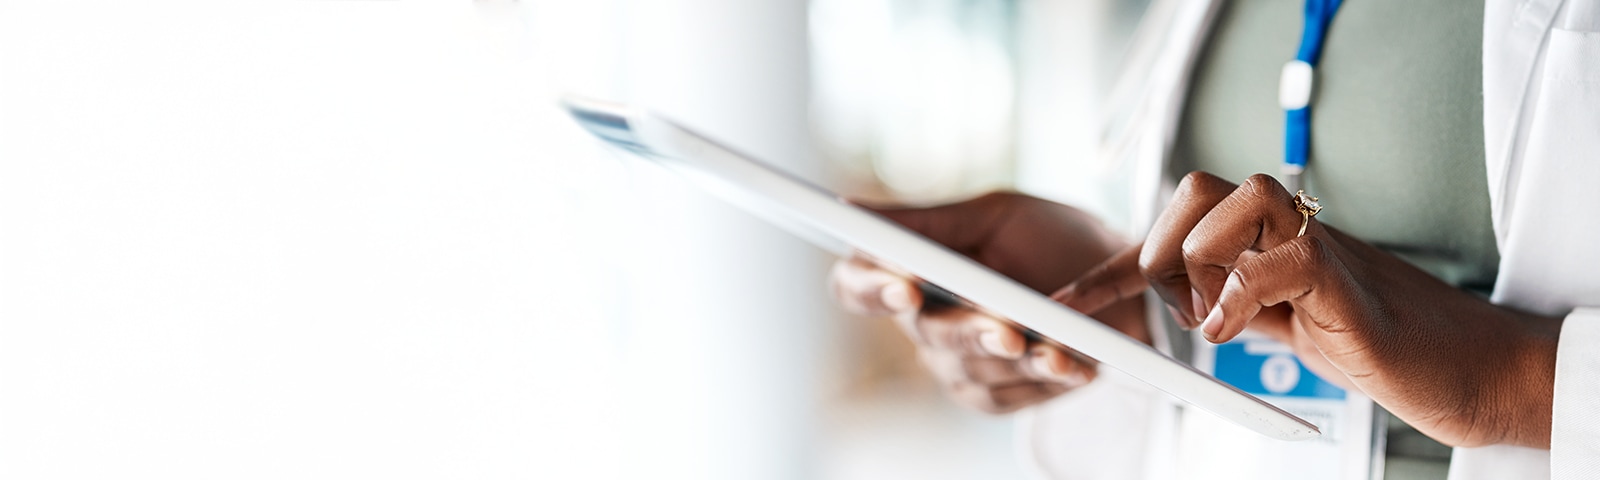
[1278,0,1342,192]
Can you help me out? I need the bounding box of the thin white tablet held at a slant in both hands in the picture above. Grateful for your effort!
[563,98,1322,440]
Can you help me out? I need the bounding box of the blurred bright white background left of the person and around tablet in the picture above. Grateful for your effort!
[0,0,1146,478]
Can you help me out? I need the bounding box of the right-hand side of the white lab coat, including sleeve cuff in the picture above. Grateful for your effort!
[1478,0,1600,480]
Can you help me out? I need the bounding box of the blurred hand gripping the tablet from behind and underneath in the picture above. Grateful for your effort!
[832,194,1149,413]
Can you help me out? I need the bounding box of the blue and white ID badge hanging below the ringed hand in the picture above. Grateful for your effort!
[1178,331,1384,480]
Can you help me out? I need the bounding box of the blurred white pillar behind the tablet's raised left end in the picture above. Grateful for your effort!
[592,0,832,478]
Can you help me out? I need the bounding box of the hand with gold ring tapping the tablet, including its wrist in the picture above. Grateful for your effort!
[1062,173,1560,448]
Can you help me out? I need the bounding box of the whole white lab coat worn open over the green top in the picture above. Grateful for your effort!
[1019,0,1600,480]
